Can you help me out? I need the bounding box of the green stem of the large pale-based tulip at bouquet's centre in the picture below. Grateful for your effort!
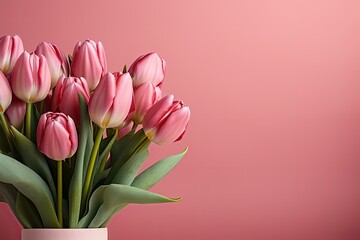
[81,128,105,210]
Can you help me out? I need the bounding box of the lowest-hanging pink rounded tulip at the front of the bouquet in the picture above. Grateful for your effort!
[36,112,78,161]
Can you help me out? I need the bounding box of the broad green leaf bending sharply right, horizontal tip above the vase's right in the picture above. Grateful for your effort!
[89,184,180,228]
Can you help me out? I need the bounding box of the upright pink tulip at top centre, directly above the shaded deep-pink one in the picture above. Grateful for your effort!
[71,40,107,91]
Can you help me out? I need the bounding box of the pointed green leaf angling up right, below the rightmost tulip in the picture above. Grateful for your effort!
[131,148,188,189]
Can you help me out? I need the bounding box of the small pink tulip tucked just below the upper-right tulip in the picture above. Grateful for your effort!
[133,83,161,124]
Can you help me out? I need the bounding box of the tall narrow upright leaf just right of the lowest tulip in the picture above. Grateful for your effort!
[69,95,92,228]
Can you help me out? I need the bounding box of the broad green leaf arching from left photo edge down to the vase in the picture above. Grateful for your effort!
[0,154,60,228]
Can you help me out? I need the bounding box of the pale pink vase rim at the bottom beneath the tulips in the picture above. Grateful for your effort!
[21,228,108,240]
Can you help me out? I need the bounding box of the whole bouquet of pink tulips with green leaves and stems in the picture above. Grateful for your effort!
[0,35,190,228]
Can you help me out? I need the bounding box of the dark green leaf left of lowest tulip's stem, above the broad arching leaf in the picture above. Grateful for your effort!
[11,126,56,198]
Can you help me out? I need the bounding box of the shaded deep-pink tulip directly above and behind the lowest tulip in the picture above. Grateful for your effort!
[52,76,90,124]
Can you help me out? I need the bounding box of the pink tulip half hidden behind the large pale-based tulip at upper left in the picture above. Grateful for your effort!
[35,42,69,88]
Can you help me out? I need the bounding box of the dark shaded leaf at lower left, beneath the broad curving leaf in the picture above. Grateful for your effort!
[0,182,31,228]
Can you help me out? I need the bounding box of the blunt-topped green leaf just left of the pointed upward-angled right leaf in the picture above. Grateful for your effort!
[112,149,149,185]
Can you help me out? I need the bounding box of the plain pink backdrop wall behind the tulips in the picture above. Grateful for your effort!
[0,0,360,240]
